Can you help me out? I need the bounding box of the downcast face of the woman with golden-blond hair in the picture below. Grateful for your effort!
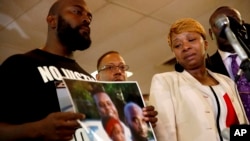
[171,32,207,70]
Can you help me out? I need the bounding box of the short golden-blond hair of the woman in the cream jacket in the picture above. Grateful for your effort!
[168,18,206,47]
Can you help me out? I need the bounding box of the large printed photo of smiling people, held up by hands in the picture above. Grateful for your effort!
[57,79,156,141]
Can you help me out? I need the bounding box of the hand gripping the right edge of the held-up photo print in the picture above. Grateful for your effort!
[142,105,158,127]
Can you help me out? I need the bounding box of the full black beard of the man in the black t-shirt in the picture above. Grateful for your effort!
[57,16,91,51]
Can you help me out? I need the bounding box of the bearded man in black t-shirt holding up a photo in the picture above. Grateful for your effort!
[0,0,95,141]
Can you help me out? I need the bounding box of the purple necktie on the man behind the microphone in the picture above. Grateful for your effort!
[230,55,250,120]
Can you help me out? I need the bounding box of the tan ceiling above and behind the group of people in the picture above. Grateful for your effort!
[0,0,250,93]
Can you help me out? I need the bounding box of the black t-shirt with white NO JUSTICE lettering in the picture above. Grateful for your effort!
[0,49,95,124]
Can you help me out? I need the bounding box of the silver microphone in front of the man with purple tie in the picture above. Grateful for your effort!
[215,14,249,82]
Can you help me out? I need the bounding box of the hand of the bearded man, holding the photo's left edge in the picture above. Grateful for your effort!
[38,112,85,141]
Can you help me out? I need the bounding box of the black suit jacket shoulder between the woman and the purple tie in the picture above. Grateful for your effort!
[206,50,230,77]
